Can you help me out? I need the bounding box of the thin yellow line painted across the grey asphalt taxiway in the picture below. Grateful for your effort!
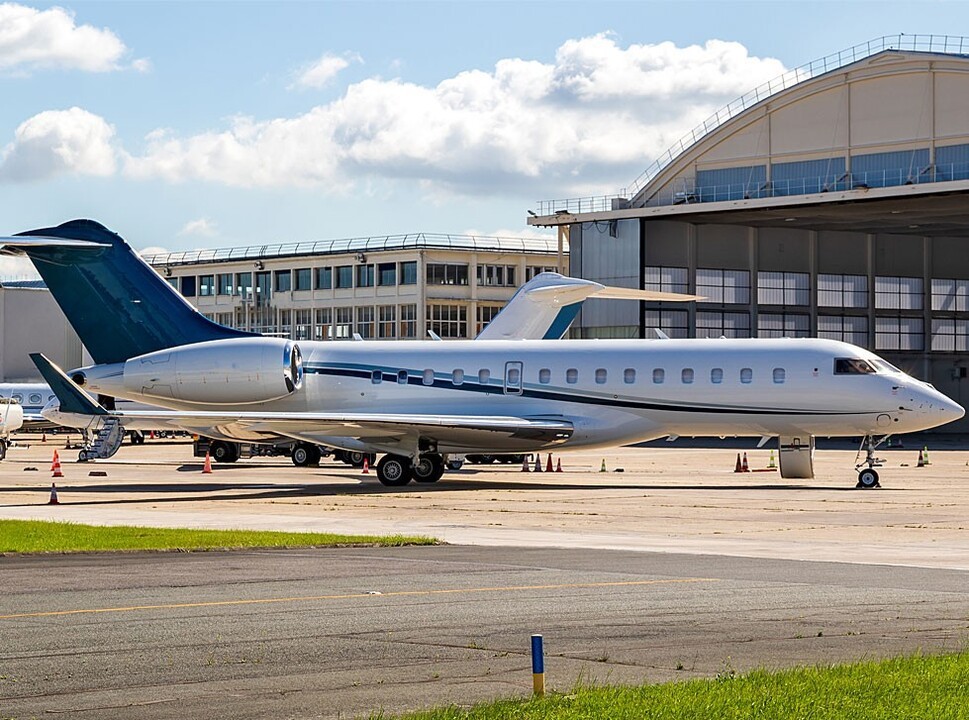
[0,578,717,620]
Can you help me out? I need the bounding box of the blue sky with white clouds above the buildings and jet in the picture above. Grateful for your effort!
[0,1,969,264]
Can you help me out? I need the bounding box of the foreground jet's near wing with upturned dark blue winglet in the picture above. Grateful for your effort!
[30,353,573,452]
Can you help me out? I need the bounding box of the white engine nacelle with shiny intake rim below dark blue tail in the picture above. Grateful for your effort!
[123,337,303,405]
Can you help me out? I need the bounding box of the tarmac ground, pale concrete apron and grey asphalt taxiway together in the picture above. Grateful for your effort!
[0,436,969,718]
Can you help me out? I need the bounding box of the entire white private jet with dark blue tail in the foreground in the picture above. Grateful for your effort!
[0,220,965,487]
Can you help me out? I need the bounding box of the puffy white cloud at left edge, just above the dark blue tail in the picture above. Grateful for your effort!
[0,107,116,182]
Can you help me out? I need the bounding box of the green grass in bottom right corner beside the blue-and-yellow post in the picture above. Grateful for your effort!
[390,651,969,720]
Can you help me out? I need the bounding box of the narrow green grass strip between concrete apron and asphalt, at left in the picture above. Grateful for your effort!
[0,520,437,553]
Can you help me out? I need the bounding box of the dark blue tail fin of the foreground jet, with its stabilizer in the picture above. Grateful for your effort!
[0,220,251,364]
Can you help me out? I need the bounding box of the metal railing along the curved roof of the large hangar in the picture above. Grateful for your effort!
[538,33,969,215]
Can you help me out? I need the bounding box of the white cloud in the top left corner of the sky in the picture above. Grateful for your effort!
[0,3,136,72]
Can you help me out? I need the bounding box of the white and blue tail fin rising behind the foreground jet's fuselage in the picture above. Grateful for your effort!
[475,272,702,340]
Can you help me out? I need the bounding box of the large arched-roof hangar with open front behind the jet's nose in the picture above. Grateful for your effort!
[528,35,969,432]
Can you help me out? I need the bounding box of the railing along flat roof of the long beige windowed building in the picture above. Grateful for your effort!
[143,233,568,267]
